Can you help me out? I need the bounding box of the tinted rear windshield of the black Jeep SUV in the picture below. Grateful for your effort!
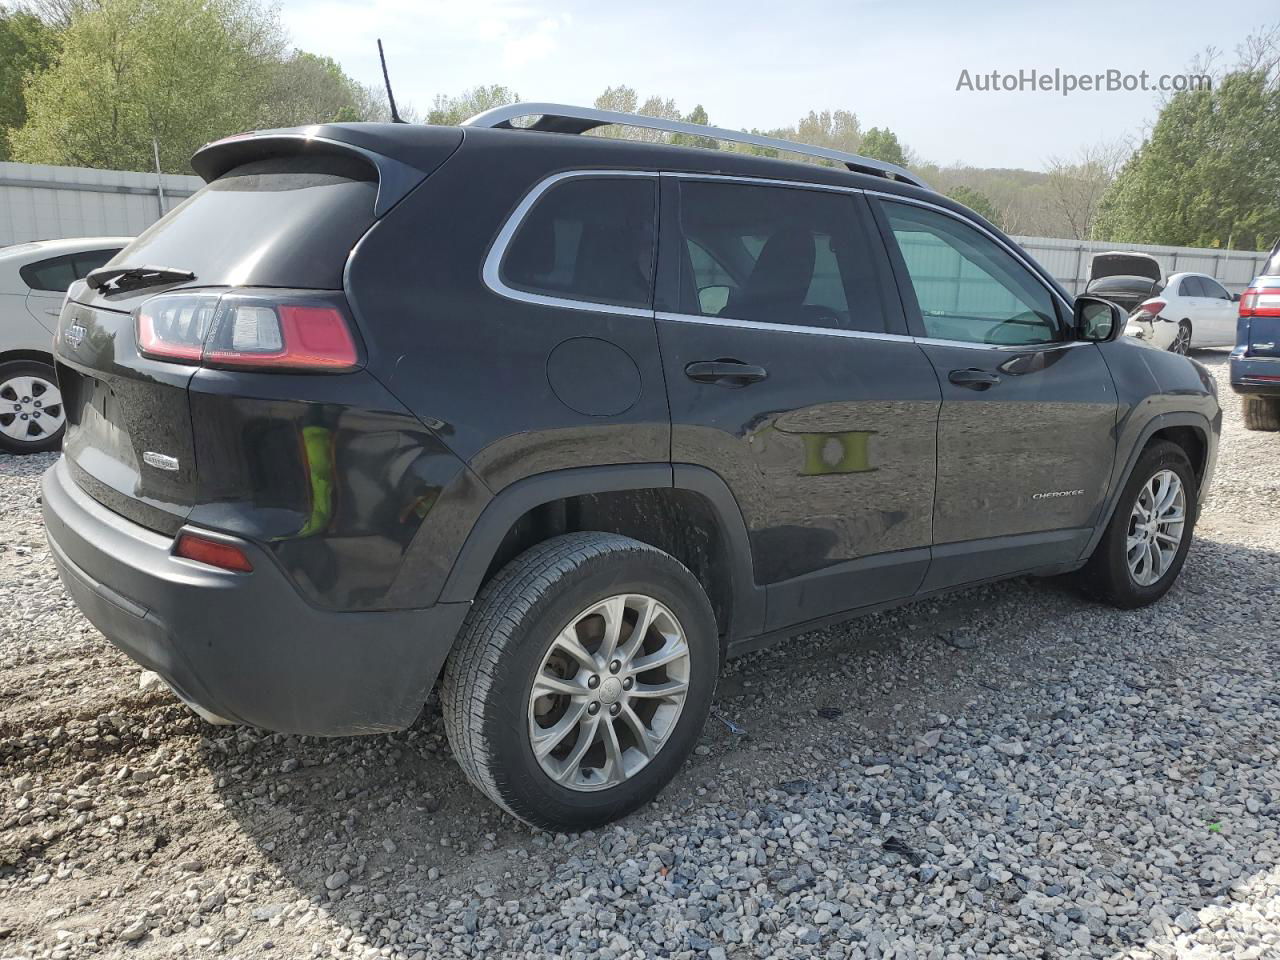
[111,156,378,289]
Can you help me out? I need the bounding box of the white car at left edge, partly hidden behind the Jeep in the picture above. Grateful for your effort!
[0,237,131,453]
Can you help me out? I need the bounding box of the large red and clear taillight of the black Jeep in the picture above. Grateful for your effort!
[134,292,360,372]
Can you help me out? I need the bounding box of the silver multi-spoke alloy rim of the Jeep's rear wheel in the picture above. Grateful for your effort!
[529,594,690,791]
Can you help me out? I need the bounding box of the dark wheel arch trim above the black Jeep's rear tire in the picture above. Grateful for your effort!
[439,463,764,643]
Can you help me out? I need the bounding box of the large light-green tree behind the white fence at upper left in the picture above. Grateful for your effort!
[10,0,284,173]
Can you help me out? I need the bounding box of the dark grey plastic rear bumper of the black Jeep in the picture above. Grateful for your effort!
[42,461,468,736]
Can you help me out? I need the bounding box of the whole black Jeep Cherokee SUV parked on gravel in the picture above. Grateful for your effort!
[44,104,1221,828]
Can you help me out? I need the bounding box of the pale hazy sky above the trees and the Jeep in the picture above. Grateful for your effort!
[280,0,1280,170]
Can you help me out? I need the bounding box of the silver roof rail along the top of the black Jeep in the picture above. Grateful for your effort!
[461,104,928,189]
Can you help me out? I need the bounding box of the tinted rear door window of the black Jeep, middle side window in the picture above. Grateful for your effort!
[680,180,884,330]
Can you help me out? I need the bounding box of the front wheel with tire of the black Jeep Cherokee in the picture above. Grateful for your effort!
[1080,440,1198,609]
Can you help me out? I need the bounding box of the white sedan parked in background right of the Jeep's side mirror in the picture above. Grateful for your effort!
[1125,274,1240,353]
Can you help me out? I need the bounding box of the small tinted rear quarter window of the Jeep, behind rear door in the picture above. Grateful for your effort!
[502,177,658,307]
